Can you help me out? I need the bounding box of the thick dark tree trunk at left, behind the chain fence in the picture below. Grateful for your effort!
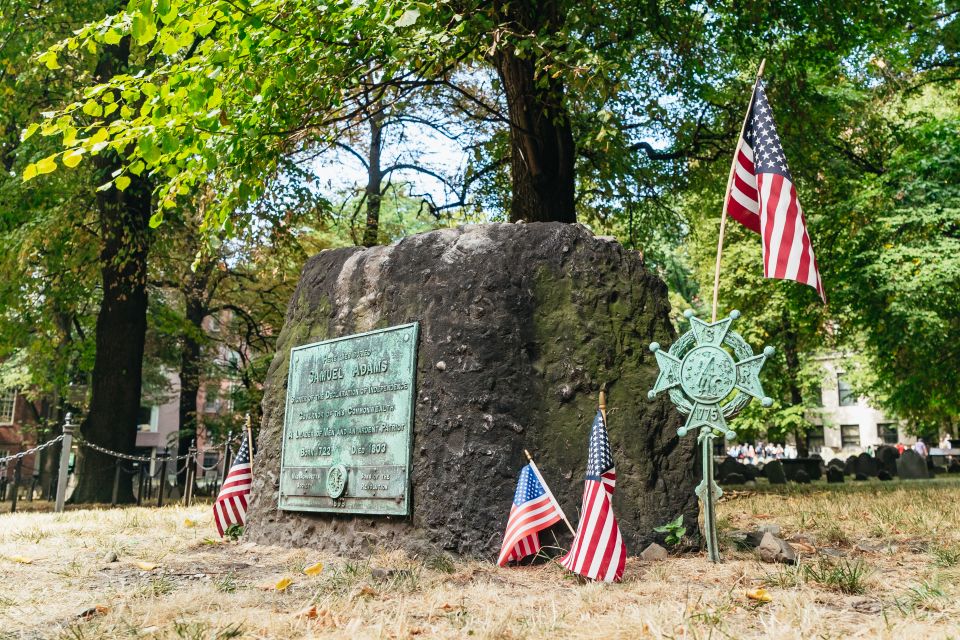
[72,38,151,503]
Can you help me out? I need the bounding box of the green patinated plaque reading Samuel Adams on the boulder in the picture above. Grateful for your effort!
[278,323,419,516]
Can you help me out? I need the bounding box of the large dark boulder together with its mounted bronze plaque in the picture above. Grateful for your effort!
[245,223,698,555]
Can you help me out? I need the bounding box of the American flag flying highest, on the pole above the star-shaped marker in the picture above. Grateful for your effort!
[726,79,827,302]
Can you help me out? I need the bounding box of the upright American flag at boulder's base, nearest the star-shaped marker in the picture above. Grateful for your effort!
[560,411,627,582]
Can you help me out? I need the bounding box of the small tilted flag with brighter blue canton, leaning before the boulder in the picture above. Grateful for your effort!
[497,462,562,567]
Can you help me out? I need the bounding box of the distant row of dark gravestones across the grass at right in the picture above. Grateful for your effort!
[716,445,960,484]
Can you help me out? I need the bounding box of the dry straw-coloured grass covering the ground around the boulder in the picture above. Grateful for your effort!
[0,480,960,640]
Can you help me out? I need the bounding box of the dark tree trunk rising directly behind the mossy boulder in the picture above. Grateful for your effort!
[493,0,577,222]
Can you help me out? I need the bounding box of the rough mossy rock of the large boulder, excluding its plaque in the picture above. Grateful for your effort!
[245,223,697,557]
